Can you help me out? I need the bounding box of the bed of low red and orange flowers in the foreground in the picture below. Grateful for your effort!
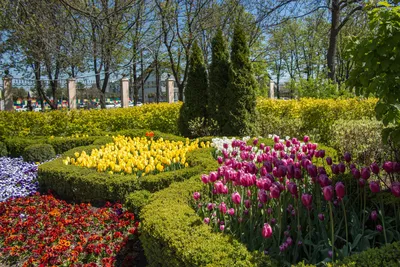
[0,194,137,266]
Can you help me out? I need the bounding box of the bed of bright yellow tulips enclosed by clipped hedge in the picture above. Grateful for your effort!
[64,136,210,177]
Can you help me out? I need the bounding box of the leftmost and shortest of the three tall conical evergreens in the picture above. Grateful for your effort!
[180,41,208,136]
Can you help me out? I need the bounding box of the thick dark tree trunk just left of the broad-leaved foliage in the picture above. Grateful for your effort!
[327,0,340,81]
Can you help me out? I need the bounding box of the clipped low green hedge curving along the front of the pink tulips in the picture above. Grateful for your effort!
[140,175,276,266]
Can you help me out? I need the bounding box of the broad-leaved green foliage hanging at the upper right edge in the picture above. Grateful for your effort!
[347,2,400,144]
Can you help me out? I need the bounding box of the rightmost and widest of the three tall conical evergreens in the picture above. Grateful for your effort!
[222,22,257,136]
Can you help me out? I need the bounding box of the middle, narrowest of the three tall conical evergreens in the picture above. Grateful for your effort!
[207,30,230,134]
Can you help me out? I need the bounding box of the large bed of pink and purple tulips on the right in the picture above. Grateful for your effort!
[193,136,400,265]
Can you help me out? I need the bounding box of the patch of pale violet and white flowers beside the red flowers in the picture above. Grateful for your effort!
[0,157,39,202]
